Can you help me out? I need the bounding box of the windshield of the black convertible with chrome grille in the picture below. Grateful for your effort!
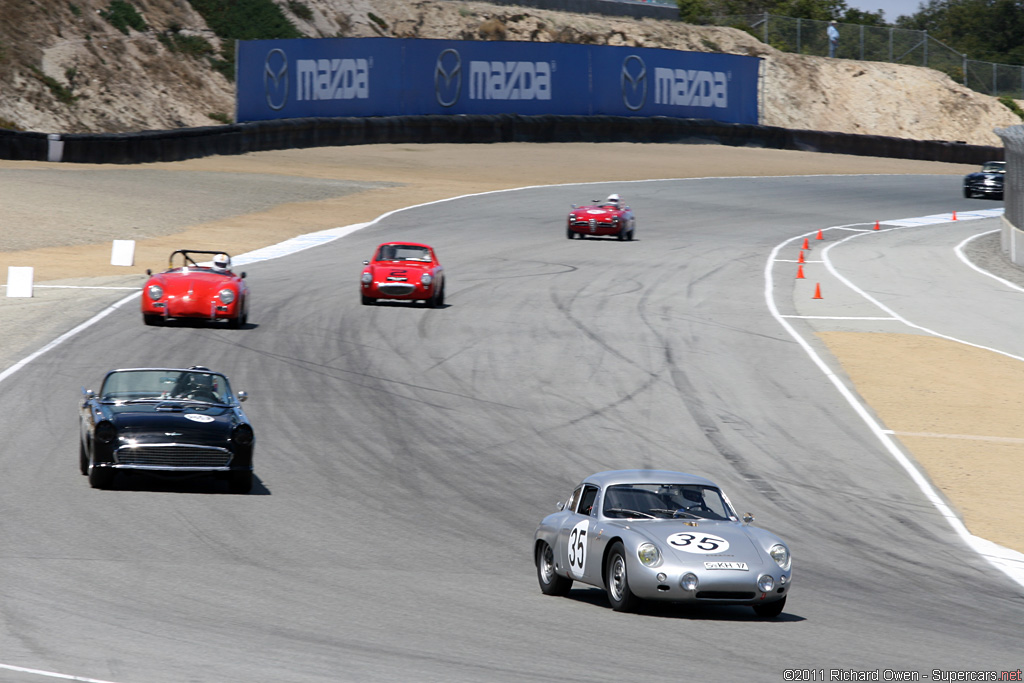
[99,370,232,403]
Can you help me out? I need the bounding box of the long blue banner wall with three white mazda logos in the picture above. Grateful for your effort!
[236,38,760,124]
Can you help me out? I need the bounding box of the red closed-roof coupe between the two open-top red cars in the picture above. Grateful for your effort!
[359,242,444,308]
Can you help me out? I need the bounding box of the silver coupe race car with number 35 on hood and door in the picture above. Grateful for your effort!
[534,470,793,617]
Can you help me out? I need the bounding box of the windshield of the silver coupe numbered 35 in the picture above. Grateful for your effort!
[602,483,736,520]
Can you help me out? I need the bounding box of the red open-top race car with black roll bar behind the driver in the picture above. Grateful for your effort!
[142,249,249,328]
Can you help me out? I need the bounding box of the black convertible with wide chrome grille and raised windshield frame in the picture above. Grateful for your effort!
[79,366,255,494]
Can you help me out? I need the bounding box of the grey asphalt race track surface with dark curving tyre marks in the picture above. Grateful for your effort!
[0,176,1024,683]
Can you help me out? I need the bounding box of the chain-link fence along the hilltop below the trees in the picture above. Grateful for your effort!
[709,13,1024,99]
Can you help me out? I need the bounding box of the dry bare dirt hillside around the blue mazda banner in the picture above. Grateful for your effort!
[0,0,1021,144]
